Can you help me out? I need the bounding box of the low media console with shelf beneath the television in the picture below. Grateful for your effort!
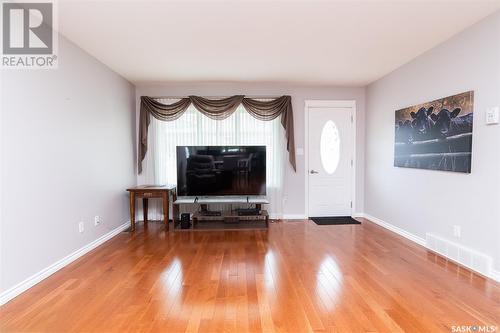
[174,196,269,228]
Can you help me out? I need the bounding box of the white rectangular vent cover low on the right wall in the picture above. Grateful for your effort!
[425,233,493,276]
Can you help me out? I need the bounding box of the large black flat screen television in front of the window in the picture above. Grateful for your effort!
[177,146,266,196]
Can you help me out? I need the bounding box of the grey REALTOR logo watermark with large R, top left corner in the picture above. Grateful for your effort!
[1,0,58,69]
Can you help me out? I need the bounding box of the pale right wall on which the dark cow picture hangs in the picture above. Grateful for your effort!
[365,13,500,271]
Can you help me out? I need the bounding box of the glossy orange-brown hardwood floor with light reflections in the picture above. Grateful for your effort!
[0,220,500,332]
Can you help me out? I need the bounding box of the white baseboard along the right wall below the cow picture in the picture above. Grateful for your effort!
[356,213,500,282]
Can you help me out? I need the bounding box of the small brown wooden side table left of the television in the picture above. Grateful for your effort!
[127,185,176,231]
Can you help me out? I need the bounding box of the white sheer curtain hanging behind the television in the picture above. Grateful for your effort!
[144,99,286,219]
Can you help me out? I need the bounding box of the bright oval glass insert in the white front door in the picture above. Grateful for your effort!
[320,120,340,175]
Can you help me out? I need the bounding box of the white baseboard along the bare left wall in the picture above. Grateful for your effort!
[0,222,130,305]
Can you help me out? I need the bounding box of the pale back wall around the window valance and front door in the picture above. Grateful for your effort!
[136,83,365,217]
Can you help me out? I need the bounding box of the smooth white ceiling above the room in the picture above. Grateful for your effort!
[58,0,500,86]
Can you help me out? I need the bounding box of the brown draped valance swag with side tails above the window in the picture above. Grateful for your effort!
[138,95,297,173]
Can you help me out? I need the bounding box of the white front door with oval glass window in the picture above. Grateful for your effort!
[306,101,354,217]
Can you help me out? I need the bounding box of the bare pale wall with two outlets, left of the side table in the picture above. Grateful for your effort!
[0,36,135,292]
